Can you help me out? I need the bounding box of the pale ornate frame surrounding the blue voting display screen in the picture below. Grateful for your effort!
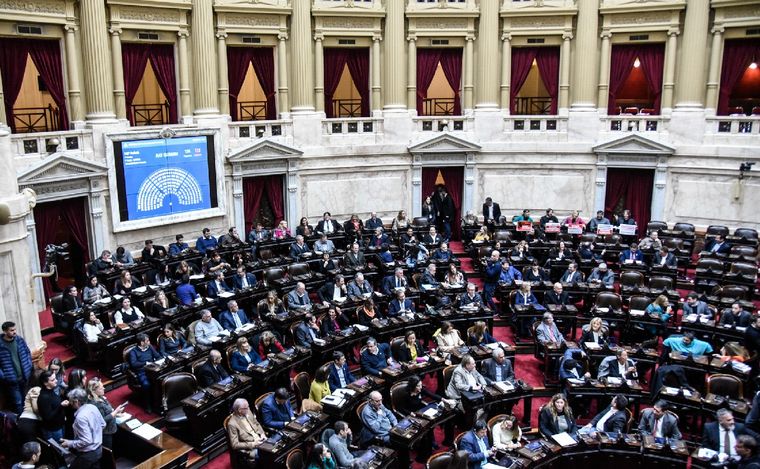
[104,127,226,233]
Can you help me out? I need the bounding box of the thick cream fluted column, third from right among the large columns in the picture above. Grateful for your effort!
[475,0,499,109]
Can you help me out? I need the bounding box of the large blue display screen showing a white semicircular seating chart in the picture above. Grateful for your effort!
[114,136,217,221]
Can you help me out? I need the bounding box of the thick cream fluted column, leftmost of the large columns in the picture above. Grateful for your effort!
[79,0,115,121]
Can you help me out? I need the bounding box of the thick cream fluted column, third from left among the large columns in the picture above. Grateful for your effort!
[290,0,314,111]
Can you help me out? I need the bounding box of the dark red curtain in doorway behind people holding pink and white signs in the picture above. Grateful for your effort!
[604,168,654,233]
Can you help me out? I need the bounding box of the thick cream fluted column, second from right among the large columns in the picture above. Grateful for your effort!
[572,0,609,110]
